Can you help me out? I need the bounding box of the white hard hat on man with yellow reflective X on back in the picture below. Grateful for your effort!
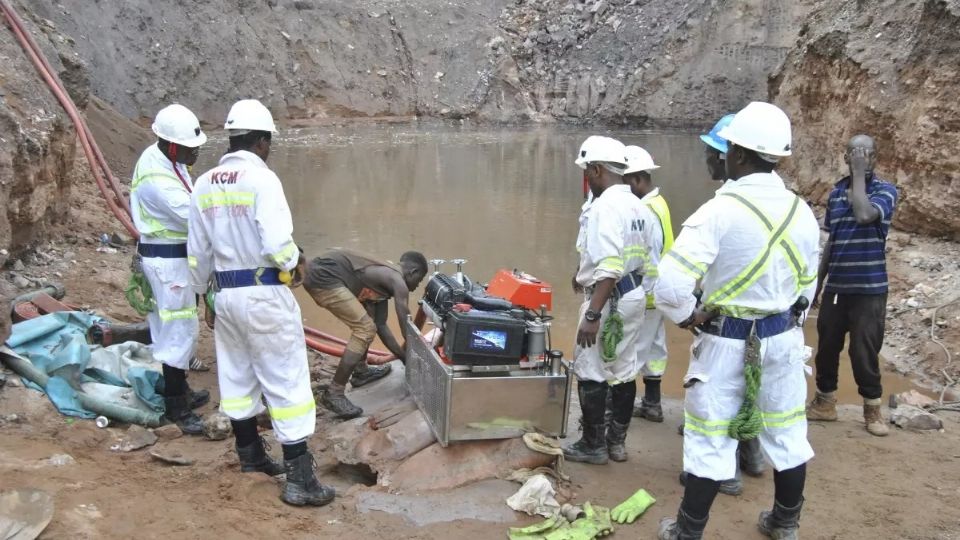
[717,101,791,162]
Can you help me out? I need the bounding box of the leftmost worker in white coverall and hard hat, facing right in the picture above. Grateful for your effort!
[130,104,210,435]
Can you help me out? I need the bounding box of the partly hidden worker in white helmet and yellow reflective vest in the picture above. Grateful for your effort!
[623,146,673,422]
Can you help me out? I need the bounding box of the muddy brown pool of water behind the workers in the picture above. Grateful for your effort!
[198,125,924,403]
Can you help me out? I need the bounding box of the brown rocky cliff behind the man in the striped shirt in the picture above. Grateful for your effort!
[771,0,960,239]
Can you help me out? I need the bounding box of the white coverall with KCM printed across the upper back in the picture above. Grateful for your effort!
[187,150,316,444]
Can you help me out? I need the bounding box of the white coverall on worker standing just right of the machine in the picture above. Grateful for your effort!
[573,184,657,384]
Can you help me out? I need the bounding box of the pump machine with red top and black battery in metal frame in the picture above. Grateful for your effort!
[406,259,572,446]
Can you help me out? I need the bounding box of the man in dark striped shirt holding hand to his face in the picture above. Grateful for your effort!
[807,135,897,436]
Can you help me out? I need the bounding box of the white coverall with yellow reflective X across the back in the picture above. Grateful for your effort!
[654,173,820,481]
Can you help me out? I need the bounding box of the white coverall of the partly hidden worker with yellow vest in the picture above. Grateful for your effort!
[637,188,672,377]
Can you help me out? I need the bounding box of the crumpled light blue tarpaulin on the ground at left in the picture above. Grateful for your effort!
[7,311,164,418]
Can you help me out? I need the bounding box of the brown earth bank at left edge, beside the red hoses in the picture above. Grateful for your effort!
[0,6,88,253]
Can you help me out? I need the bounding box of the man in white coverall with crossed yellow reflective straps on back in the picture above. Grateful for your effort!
[654,102,819,540]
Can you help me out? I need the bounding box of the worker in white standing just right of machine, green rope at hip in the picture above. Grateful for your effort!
[564,136,656,464]
